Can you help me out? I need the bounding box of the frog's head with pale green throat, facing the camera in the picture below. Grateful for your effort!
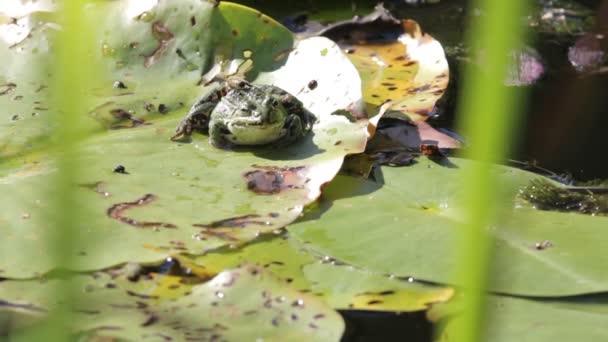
[211,87,287,145]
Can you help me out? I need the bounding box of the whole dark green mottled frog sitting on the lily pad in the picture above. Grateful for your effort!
[171,77,316,148]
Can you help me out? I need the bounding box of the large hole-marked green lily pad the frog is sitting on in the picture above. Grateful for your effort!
[0,0,368,278]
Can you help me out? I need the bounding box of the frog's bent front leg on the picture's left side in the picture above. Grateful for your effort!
[171,89,224,141]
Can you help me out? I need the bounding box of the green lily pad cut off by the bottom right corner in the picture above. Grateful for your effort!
[429,296,608,342]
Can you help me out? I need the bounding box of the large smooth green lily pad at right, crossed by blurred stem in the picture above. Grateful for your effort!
[289,159,608,296]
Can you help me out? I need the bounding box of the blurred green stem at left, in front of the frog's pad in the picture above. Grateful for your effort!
[20,0,94,341]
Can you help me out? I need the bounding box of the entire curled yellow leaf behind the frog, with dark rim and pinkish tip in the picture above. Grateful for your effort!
[319,4,460,148]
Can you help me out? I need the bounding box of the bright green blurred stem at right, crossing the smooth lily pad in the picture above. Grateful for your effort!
[453,0,526,342]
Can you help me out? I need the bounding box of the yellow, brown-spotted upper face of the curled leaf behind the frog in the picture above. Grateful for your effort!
[344,20,449,122]
